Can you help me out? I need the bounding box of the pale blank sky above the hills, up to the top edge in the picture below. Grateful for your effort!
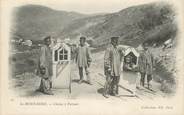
[6,0,171,14]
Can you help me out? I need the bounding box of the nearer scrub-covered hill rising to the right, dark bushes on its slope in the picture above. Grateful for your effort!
[60,3,176,47]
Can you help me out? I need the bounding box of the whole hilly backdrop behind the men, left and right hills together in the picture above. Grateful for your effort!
[12,3,177,47]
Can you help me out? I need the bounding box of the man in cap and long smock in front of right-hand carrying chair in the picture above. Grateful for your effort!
[103,37,124,97]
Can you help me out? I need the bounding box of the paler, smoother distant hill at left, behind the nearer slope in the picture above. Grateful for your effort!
[12,5,86,40]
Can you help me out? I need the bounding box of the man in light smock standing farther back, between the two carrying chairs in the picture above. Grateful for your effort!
[76,37,92,85]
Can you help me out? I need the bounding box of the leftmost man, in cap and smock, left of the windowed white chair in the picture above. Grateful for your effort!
[38,36,53,95]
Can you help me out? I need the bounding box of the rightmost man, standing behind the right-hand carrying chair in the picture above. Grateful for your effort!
[138,42,155,89]
